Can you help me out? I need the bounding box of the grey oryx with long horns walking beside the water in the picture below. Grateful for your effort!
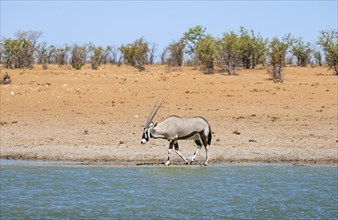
[141,101,211,166]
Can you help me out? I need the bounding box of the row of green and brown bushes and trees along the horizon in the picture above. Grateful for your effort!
[0,26,338,83]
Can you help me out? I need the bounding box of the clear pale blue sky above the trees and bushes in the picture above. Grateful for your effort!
[1,0,338,49]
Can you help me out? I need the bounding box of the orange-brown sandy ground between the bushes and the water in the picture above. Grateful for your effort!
[0,65,338,165]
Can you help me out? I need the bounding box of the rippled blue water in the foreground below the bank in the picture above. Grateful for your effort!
[0,164,338,219]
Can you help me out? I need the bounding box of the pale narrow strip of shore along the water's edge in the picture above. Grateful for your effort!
[0,144,338,166]
